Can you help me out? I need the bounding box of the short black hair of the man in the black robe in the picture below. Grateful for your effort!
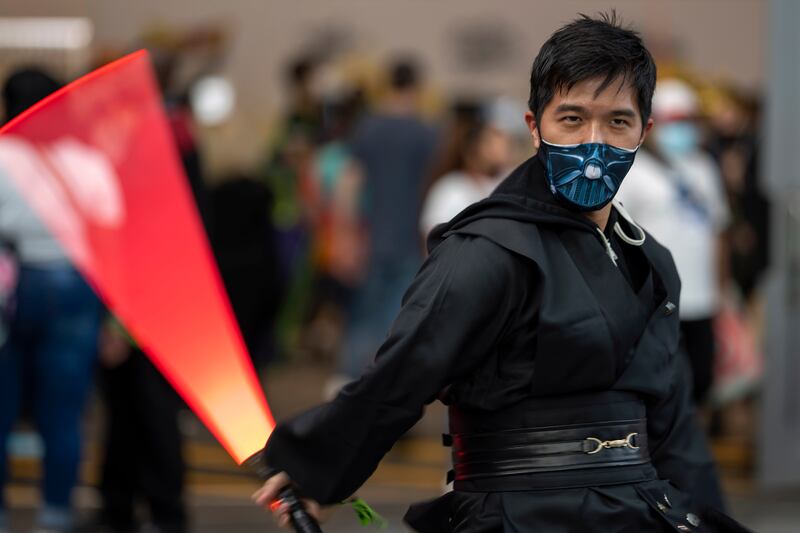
[528,11,656,127]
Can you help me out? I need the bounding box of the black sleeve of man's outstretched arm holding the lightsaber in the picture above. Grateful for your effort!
[265,235,518,504]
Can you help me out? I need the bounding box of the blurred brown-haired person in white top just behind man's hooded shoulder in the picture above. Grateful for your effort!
[420,118,511,236]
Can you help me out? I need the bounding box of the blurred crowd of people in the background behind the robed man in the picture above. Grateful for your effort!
[0,5,770,531]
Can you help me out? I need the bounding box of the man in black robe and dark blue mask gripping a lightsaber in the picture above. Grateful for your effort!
[255,12,742,533]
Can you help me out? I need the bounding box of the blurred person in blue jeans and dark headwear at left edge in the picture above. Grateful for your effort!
[0,69,102,532]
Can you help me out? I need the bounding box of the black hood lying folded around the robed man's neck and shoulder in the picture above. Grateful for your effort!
[428,156,604,252]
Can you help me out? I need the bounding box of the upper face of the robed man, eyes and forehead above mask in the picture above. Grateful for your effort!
[525,78,653,150]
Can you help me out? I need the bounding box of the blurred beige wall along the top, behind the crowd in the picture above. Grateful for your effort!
[0,0,766,172]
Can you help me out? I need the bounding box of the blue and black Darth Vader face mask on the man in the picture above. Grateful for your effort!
[537,140,639,211]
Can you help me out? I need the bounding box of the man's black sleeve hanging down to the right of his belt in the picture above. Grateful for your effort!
[647,344,724,511]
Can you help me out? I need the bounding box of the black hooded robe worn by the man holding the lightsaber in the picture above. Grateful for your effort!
[265,158,752,533]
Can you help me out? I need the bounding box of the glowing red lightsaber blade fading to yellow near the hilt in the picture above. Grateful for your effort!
[0,51,319,531]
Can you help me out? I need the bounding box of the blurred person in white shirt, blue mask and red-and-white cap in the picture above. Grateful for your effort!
[619,79,730,405]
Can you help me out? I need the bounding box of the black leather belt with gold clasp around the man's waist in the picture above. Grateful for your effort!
[451,419,650,483]
